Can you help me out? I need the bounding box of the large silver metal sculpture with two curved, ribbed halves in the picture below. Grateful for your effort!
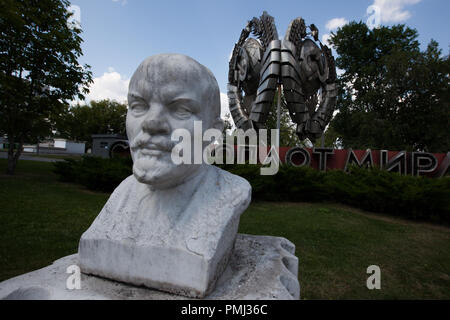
[228,11,337,142]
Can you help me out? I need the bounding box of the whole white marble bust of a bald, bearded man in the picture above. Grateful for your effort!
[79,54,251,297]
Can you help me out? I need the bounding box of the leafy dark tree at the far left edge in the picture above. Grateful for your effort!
[0,0,92,174]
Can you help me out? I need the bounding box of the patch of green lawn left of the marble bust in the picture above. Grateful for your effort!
[0,159,108,280]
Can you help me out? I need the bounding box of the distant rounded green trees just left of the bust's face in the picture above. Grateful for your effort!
[55,100,127,148]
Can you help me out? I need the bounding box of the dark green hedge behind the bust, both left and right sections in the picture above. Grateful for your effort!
[55,157,450,224]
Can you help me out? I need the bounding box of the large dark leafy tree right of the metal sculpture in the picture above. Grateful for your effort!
[330,22,450,152]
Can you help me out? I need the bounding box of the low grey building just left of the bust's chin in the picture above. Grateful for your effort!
[92,134,130,158]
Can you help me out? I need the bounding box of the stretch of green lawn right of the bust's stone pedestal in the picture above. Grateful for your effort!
[239,203,450,299]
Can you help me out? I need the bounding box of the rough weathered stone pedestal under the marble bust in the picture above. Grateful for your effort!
[0,234,300,300]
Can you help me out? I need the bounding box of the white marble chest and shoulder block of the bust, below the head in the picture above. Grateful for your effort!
[79,166,251,297]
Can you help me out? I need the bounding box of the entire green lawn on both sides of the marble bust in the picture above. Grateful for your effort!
[0,159,450,299]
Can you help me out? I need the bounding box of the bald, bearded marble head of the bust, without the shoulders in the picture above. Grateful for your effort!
[126,54,223,189]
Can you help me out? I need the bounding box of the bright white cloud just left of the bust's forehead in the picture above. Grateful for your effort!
[87,67,130,103]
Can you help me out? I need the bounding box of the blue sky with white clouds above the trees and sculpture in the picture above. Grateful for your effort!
[67,0,450,117]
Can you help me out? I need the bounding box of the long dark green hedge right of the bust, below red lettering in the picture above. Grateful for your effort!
[216,165,450,224]
